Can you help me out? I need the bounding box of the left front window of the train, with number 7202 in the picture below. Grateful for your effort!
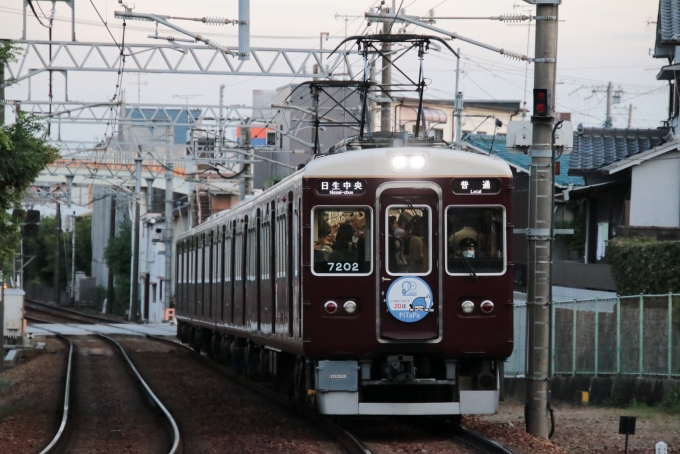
[312,207,372,274]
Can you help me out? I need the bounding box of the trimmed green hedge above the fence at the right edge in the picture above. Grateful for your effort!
[607,237,680,295]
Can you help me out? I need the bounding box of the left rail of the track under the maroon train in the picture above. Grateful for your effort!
[146,335,371,454]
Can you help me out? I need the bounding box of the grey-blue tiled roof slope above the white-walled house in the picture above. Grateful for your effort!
[569,128,669,175]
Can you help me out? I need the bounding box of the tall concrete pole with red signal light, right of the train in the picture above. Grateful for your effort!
[525,0,561,438]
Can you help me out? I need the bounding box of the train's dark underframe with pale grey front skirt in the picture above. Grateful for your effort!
[177,321,503,415]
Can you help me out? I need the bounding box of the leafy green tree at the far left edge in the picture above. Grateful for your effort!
[0,41,59,270]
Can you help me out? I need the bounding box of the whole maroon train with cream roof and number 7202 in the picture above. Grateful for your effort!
[175,148,513,415]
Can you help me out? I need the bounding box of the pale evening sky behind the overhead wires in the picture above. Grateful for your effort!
[0,0,668,139]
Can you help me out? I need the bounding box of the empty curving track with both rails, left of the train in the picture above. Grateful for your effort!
[41,335,179,454]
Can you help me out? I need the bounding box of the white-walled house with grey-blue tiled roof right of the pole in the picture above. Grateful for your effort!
[563,127,680,263]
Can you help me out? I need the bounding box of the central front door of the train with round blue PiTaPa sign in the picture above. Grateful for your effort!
[377,182,442,342]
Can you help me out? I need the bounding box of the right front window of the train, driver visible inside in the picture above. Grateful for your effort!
[446,206,506,274]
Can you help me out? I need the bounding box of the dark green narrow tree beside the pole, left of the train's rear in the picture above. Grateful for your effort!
[104,221,132,315]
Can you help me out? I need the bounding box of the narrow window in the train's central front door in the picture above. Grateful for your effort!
[385,205,432,275]
